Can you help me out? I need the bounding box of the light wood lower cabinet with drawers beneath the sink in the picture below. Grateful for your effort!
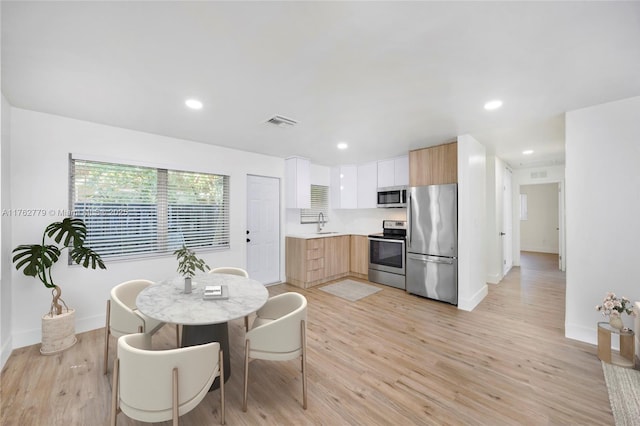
[285,235,351,288]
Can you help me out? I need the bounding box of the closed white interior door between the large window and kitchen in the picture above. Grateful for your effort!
[247,175,280,284]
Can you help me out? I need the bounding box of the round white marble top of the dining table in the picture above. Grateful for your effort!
[136,273,269,325]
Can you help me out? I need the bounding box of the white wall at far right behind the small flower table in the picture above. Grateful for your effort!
[565,97,640,343]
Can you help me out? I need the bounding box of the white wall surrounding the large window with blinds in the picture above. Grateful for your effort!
[9,108,285,347]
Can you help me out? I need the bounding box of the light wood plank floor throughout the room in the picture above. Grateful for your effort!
[0,253,613,426]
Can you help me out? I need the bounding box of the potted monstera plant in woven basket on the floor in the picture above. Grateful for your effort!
[13,217,106,355]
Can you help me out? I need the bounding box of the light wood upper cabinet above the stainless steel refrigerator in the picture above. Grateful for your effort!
[409,142,458,186]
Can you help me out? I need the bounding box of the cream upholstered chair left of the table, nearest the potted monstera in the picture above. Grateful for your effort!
[104,280,165,374]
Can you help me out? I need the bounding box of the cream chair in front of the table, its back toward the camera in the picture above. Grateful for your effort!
[111,333,225,426]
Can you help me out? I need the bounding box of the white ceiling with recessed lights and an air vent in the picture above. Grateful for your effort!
[2,1,640,167]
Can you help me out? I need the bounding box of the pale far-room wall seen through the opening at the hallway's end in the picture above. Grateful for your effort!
[515,183,560,254]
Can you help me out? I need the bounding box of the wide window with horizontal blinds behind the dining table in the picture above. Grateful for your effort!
[70,159,229,259]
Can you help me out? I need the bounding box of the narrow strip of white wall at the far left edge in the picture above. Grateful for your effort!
[0,96,12,369]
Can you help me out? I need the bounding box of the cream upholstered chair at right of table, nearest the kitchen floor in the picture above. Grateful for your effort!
[242,292,307,411]
